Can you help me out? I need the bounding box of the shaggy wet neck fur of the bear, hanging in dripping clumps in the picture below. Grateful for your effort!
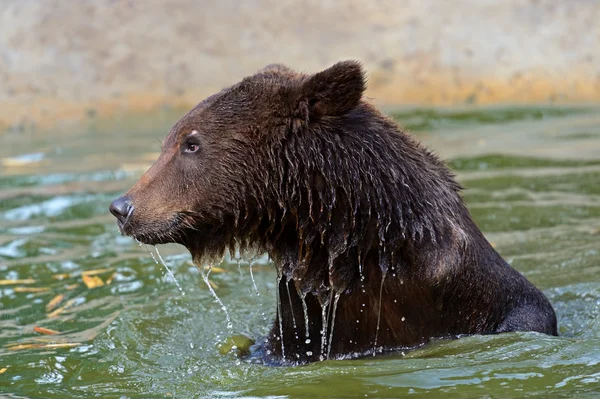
[257,103,478,293]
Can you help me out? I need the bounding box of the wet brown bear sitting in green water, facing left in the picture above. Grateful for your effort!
[110,61,557,364]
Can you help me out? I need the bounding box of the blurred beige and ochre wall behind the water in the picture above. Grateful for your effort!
[0,0,600,129]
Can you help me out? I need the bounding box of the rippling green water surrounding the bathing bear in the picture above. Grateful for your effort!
[0,108,600,398]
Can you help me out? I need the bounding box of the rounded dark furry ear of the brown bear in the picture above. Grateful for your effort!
[296,61,366,120]
